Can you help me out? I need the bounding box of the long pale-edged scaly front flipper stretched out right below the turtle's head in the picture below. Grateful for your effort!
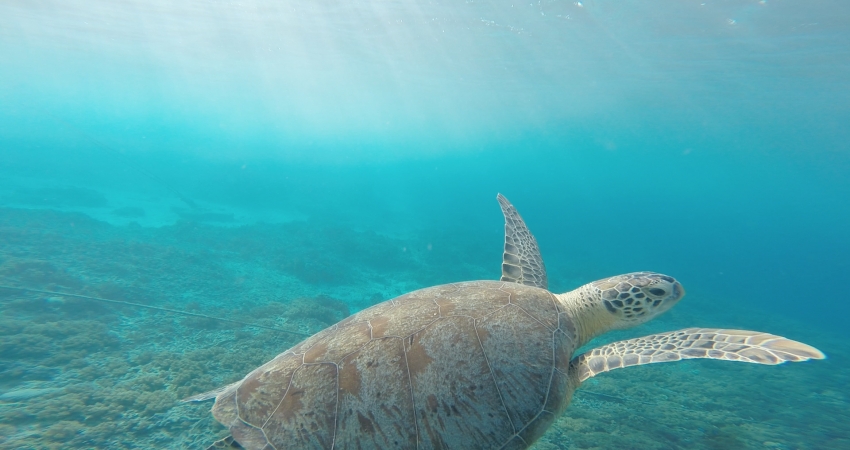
[570,328,826,382]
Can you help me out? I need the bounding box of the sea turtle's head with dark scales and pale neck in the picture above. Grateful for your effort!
[590,272,685,329]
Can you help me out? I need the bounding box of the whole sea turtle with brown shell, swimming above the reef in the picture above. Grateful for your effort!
[186,194,824,450]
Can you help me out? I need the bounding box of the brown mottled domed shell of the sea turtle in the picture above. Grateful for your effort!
[213,281,577,450]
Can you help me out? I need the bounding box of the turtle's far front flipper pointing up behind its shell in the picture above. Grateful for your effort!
[496,194,549,289]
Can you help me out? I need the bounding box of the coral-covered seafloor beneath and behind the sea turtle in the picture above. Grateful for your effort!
[0,208,850,450]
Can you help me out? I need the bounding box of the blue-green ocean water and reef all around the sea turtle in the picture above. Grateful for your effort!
[0,0,850,450]
